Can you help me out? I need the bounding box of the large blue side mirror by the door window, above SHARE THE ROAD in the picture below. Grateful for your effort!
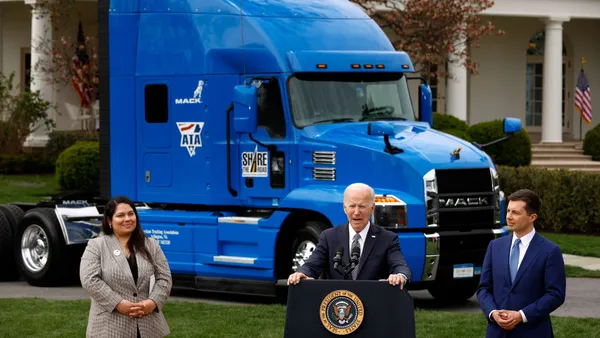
[233,85,258,134]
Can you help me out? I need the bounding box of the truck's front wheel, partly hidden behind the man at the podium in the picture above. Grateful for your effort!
[286,221,328,278]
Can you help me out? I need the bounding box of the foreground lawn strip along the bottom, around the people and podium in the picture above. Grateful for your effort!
[0,299,600,338]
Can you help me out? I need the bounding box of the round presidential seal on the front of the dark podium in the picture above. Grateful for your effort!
[319,290,365,335]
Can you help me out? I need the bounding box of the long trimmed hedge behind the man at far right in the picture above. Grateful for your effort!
[497,166,600,234]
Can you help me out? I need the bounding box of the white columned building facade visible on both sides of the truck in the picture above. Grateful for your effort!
[0,0,600,146]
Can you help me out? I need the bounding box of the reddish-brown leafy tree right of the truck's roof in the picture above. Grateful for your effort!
[350,0,504,81]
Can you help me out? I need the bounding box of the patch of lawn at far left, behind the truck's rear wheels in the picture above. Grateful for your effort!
[0,175,59,204]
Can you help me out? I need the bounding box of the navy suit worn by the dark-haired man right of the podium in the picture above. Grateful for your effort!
[477,233,567,337]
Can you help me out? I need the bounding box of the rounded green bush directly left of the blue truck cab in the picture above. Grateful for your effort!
[56,141,100,193]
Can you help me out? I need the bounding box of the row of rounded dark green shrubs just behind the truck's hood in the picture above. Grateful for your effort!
[433,113,532,167]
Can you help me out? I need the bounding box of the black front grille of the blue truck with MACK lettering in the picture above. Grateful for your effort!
[436,168,496,228]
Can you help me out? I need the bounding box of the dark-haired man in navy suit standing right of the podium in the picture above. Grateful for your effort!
[477,189,567,337]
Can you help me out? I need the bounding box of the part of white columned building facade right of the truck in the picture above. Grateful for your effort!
[414,0,600,143]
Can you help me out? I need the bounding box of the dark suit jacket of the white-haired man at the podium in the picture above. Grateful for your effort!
[298,223,411,280]
